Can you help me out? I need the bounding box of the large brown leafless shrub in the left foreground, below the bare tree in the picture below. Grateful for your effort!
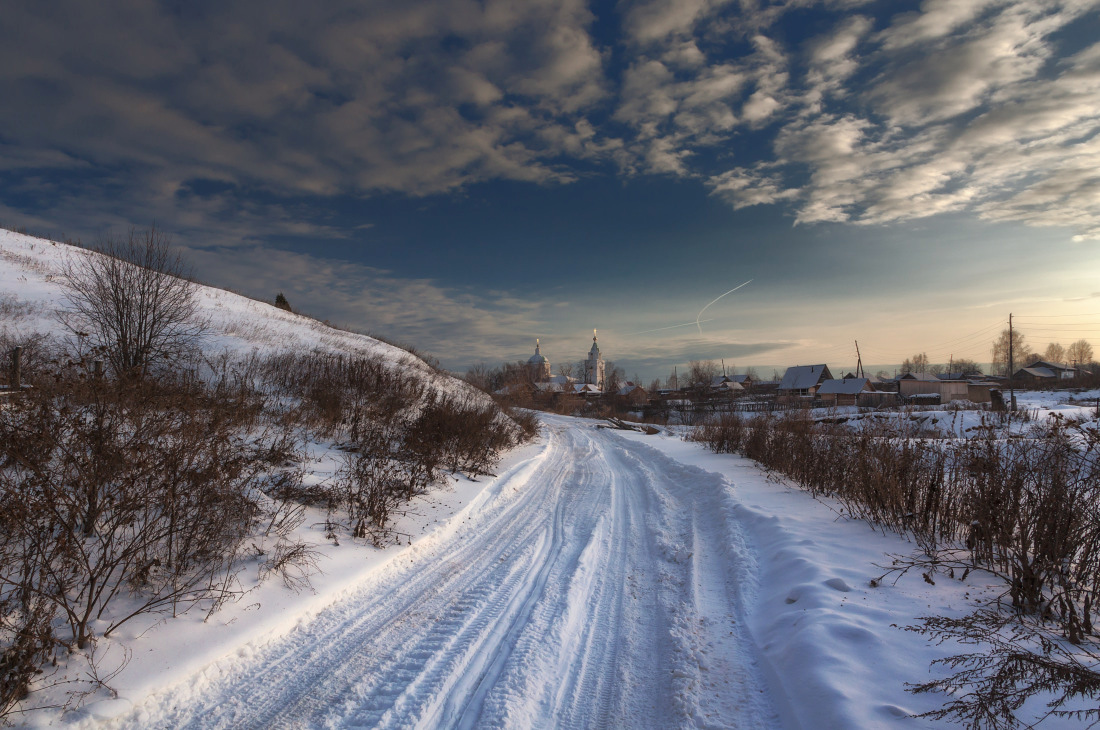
[0,367,266,648]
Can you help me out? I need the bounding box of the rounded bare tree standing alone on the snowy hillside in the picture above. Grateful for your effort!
[61,225,205,376]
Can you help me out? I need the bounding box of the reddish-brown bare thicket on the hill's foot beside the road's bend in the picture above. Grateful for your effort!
[260,353,537,544]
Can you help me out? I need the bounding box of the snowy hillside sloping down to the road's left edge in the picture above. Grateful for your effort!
[0,231,532,725]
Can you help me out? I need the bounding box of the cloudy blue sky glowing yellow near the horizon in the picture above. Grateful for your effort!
[0,0,1100,379]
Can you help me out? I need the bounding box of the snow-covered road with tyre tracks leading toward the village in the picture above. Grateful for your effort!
[101,418,780,728]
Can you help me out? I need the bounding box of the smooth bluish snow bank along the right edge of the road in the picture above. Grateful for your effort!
[623,432,1076,730]
